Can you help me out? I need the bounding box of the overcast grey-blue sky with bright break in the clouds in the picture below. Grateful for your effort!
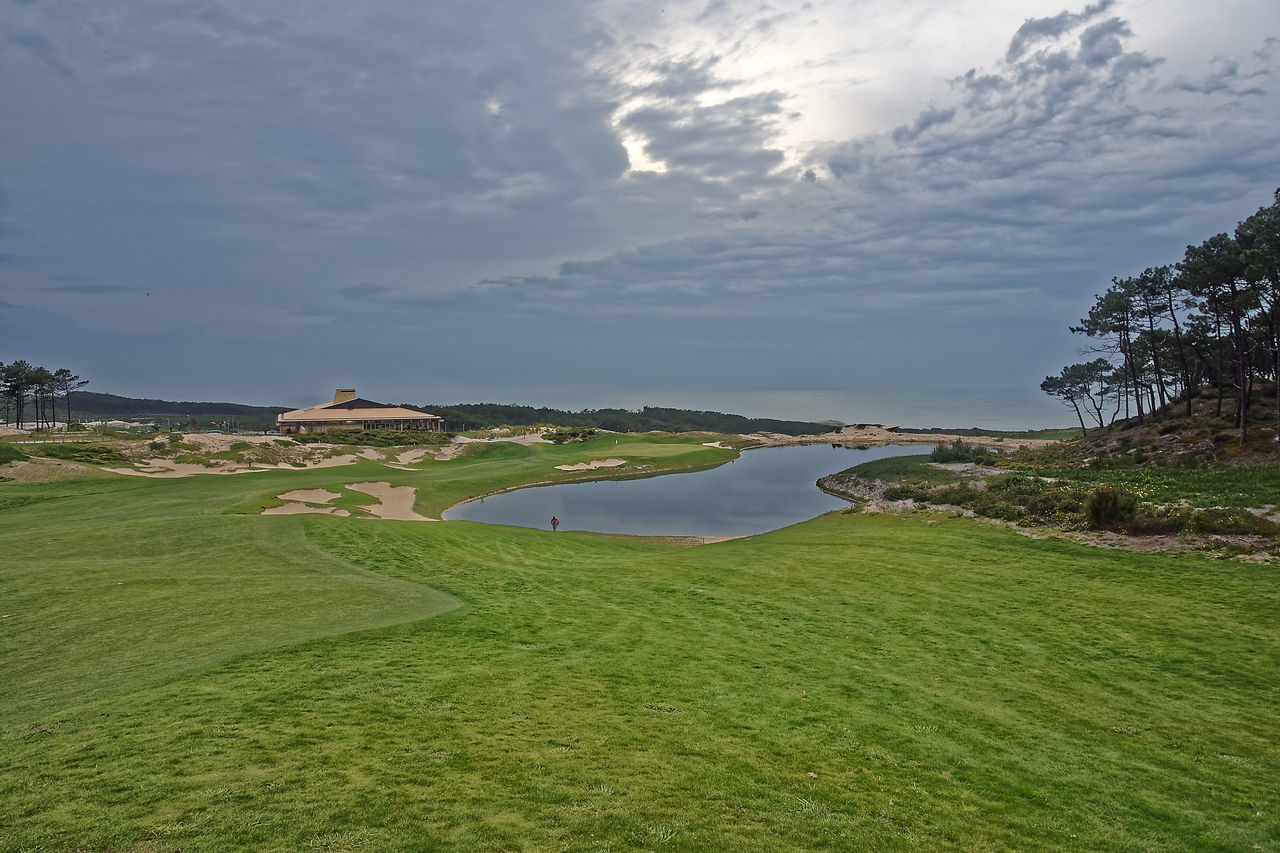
[0,0,1280,427]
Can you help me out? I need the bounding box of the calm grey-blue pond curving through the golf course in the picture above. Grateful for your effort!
[444,444,933,537]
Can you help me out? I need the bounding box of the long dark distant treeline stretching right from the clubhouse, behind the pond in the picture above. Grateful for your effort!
[404,403,831,435]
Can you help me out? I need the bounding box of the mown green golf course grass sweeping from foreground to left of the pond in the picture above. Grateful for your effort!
[0,437,1280,850]
